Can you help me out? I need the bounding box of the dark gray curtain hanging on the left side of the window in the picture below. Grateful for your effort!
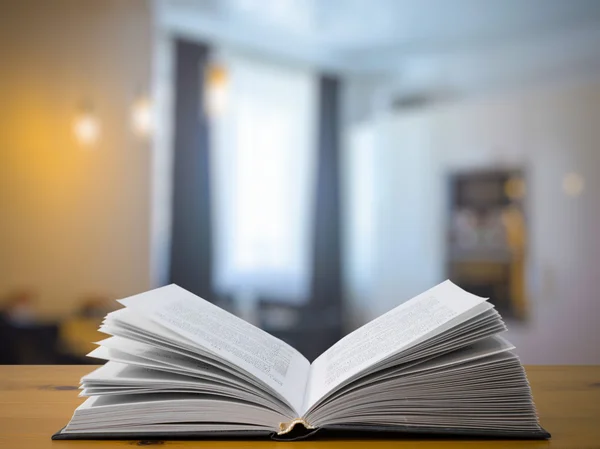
[170,41,214,300]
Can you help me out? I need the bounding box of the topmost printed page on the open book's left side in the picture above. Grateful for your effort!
[119,285,310,411]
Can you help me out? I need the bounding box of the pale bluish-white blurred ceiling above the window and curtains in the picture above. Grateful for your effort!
[156,0,600,93]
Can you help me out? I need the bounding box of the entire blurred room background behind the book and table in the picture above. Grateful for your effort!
[0,0,600,364]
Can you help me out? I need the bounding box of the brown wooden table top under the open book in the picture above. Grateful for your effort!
[0,365,600,449]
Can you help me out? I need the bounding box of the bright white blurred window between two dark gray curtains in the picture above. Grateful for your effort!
[211,54,316,304]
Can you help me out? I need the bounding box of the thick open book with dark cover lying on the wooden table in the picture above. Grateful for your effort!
[53,281,550,439]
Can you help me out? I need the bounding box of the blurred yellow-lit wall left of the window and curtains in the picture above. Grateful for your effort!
[0,0,152,316]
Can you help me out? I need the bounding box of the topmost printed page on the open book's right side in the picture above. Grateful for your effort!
[303,281,485,411]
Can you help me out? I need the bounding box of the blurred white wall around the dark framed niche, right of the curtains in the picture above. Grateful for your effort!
[346,76,600,364]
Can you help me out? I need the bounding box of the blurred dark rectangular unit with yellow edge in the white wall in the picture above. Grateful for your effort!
[446,170,527,320]
